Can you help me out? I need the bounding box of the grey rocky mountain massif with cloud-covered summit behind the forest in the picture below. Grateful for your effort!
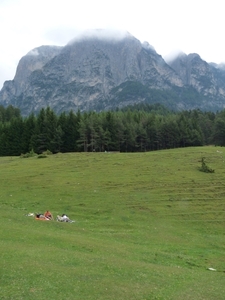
[0,30,225,115]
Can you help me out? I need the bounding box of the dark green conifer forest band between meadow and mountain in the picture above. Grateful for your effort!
[0,104,225,156]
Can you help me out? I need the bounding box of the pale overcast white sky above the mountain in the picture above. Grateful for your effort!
[0,0,225,88]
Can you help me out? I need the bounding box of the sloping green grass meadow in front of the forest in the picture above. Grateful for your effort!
[0,146,225,300]
